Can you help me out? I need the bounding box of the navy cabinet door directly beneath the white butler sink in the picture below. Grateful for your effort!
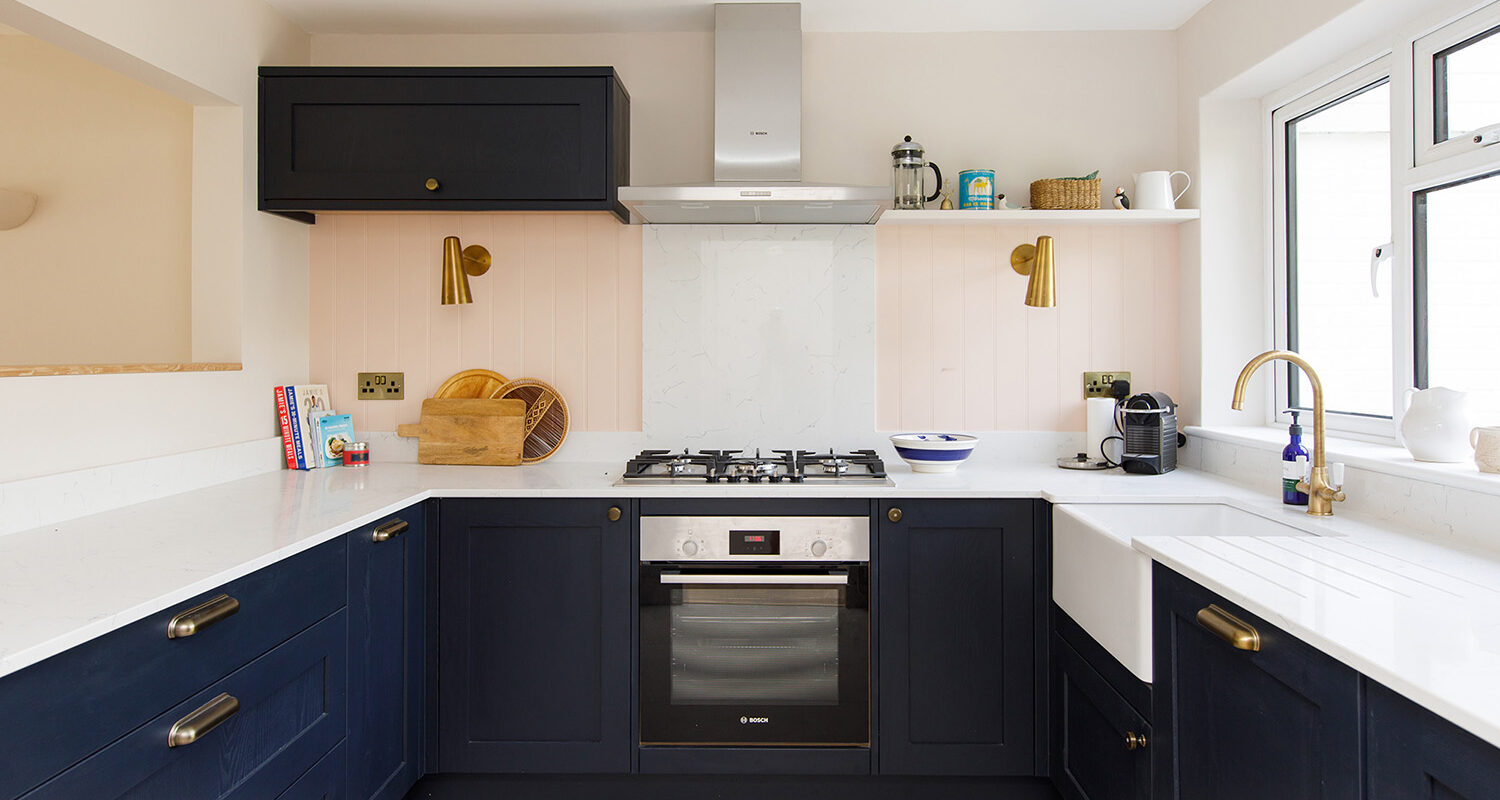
[1052,606,1152,800]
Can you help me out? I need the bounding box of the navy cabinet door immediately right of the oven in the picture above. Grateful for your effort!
[875,500,1049,776]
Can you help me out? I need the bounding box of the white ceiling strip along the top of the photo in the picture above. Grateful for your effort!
[267,0,1209,35]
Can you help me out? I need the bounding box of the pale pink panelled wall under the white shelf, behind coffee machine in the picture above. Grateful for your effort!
[875,225,1179,431]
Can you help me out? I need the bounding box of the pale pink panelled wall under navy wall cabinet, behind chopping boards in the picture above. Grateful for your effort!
[309,213,641,431]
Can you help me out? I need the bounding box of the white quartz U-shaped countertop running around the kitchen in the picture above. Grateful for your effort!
[0,461,1500,746]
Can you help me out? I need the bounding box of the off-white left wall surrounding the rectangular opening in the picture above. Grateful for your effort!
[0,0,308,480]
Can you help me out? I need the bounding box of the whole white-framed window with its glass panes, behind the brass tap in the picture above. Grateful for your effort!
[1271,3,1500,437]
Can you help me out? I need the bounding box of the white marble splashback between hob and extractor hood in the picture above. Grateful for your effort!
[641,225,875,449]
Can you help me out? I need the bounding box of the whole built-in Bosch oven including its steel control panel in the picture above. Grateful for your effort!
[639,516,870,747]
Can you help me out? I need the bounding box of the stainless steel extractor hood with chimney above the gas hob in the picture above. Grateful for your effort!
[620,3,891,225]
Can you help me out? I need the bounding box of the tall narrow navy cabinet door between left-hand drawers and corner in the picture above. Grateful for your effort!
[345,504,426,800]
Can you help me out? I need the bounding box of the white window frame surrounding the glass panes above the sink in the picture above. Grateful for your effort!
[1262,0,1500,443]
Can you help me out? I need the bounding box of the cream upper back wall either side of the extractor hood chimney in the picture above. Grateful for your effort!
[312,32,1178,198]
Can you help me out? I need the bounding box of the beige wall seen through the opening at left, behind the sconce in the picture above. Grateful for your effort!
[0,35,194,365]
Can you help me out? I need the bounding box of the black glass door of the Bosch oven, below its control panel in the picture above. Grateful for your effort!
[641,563,870,746]
